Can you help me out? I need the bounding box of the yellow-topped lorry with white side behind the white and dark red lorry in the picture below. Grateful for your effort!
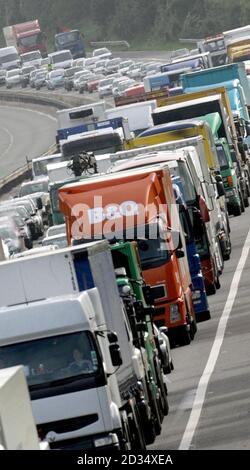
[127,126,229,294]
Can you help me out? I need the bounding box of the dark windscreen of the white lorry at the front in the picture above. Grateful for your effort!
[0,331,102,396]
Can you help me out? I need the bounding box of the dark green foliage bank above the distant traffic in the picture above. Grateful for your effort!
[0,0,250,47]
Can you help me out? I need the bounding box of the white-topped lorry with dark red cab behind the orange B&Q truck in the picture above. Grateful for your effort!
[110,140,222,295]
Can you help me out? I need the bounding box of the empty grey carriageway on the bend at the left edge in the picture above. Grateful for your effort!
[0,105,57,178]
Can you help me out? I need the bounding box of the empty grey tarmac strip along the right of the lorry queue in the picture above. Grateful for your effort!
[150,209,250,450]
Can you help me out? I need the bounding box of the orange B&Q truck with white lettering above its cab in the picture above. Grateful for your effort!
[59,165,196,345]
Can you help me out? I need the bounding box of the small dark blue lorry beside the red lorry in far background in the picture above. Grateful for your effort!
[55,29,86,59]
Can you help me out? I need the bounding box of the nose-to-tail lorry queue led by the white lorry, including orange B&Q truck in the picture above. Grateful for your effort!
[0,23,250,452]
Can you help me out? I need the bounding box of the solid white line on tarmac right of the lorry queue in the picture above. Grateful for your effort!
[179,230,250,450]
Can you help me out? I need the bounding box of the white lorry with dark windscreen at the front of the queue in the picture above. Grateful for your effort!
[0,241,166,451]
